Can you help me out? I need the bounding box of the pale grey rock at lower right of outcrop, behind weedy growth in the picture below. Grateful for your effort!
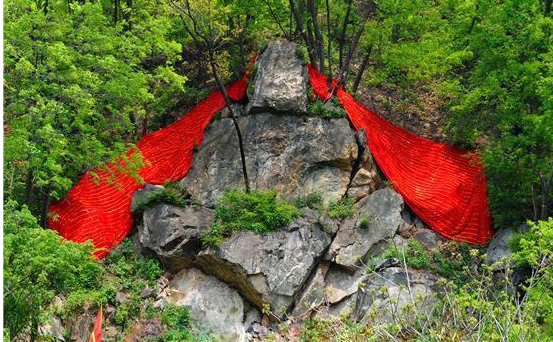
[355,267,437,324]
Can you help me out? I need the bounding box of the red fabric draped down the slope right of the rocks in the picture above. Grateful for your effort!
[309,66,493,244]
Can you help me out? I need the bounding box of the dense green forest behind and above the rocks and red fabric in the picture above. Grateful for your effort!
[4,0,553,340]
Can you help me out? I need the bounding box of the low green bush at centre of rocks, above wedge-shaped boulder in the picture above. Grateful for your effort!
[202,190,299,245]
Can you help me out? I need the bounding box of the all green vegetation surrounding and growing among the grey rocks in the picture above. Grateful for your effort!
[3,0,553,341]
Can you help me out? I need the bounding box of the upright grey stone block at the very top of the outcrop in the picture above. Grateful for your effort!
[250,40,307,114]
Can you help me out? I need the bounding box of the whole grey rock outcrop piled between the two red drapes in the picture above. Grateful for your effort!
[115,41,458,341]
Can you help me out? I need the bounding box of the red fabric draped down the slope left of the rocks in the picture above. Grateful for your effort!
[49,57,255,258]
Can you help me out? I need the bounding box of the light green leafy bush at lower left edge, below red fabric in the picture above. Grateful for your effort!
[4,201,105,339]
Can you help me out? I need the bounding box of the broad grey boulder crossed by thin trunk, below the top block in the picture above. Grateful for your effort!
[182,113,357,206]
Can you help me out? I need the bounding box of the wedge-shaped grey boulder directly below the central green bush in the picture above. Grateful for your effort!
[196,218,330,316]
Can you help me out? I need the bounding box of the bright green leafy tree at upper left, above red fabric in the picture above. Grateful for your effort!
[4,0,186,226]
